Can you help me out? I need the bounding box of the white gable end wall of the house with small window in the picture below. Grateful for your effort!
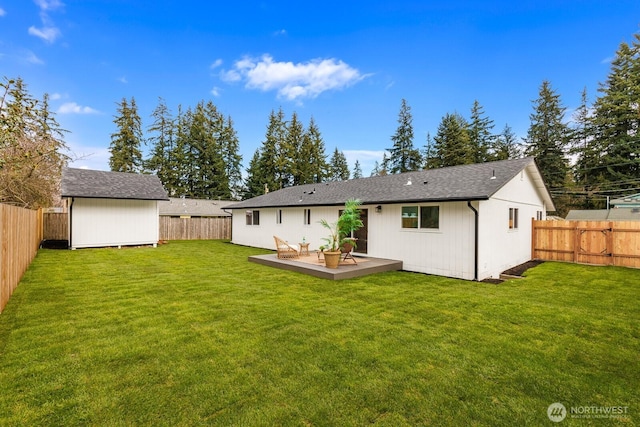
[478,169,546,280]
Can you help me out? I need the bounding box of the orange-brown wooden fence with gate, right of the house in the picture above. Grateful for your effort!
[531,220,640,268]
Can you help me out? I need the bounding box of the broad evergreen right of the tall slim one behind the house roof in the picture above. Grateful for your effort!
[432,113,474,167]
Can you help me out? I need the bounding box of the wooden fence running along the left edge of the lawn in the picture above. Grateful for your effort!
[0,204,43,313]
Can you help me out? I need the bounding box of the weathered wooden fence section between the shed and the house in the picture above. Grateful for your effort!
[160,216,231,240]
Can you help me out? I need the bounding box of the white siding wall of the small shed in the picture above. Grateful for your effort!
[70,198,159,249]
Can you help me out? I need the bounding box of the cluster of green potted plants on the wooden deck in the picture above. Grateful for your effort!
[320,199,363,268]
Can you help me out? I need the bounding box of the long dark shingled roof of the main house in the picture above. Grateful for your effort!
[227,157,555,210]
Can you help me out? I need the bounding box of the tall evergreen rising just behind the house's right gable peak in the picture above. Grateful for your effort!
[524,80,570,192]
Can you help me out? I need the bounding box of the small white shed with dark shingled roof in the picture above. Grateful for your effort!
[62,168,167,249]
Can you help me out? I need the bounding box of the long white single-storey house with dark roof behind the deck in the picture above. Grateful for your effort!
[227,158,555,280]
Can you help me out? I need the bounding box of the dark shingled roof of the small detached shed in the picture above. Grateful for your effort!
[61,168,168,200]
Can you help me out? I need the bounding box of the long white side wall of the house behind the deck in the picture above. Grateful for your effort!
[232,202,474,280]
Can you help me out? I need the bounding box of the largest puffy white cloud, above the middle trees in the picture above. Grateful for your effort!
[220,55,367,100]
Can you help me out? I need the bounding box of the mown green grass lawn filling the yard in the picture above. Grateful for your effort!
[0,241,640,426]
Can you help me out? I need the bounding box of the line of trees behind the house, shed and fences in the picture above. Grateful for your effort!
[0,28,640,214]
